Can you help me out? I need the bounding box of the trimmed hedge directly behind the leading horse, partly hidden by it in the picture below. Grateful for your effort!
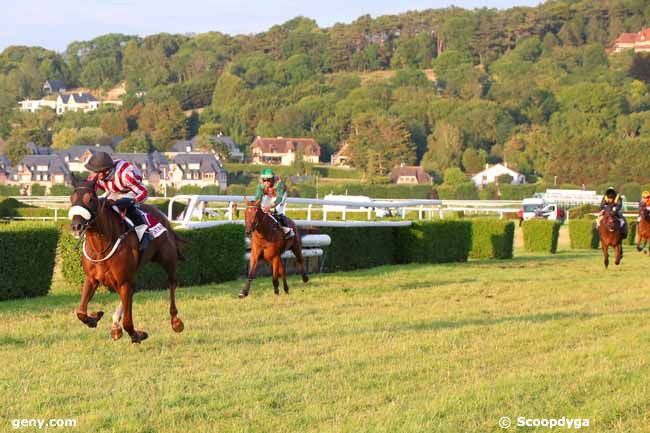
[59,224,246,290]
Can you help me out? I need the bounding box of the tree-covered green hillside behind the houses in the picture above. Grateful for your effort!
[0,0,650,184]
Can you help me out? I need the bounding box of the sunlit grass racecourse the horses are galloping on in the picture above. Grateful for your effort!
[0,228,650,433]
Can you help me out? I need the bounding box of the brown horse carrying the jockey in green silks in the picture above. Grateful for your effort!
[239,200,309,298]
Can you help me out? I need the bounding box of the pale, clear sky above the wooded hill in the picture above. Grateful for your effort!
[0,0,541,52]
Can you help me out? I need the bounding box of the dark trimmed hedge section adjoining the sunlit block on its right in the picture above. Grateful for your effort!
[395,220,472,263]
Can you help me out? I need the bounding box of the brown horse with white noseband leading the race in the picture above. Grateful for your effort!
[69,177,184,343]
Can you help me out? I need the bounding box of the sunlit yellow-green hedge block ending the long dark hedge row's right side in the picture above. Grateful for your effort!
[470,218,515,259]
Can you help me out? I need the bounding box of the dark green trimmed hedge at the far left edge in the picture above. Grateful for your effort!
[0,222,58,300]
